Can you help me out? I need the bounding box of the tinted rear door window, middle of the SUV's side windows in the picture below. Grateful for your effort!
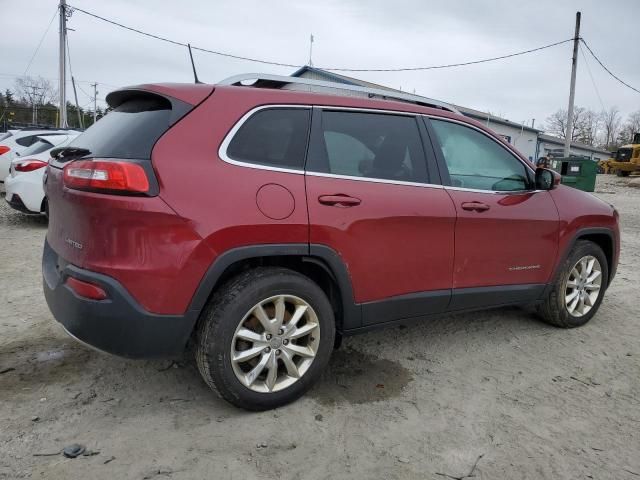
[307,110,428,182]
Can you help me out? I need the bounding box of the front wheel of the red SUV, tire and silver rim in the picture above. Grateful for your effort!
[538,240,609,328]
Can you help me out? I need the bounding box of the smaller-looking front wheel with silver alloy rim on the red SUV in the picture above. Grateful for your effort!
[538,240,609,328]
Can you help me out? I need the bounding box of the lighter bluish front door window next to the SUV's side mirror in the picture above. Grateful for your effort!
[431,120,529,192]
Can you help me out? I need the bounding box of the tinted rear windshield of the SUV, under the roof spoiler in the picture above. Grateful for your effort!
[69,95,171,159]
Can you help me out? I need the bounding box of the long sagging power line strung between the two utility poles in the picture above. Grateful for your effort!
[69,5,573,72]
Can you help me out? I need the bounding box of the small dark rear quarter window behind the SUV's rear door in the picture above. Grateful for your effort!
[227,108,310,170]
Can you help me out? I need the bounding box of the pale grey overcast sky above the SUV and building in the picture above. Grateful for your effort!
[0,0,640,126]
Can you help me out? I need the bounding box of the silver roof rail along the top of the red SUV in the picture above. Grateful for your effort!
[218,73,460,114]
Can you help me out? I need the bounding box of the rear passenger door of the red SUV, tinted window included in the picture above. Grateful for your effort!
[306,109,455,328]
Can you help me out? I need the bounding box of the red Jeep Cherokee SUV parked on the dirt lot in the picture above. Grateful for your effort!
[43,75,620,410]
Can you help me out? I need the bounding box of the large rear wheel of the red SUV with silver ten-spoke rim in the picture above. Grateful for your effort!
[195,267,335,411]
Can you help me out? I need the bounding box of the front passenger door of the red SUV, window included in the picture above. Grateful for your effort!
[430,119,559,310]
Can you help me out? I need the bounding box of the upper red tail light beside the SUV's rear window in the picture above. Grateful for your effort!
[63,160,149,193]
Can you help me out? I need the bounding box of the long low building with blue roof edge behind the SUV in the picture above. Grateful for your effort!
[284,65,609,161]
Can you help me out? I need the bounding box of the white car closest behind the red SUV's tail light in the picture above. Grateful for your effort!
[5,132,79,215]
